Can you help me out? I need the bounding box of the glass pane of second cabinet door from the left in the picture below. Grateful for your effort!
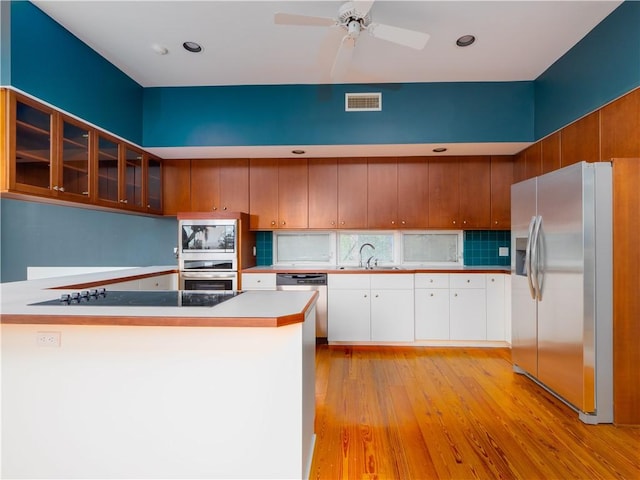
[58,120,89,197]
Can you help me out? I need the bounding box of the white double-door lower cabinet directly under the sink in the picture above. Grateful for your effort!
[328,274,414,342]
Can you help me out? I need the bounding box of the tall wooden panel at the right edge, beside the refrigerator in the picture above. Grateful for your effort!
[613,158,640,425]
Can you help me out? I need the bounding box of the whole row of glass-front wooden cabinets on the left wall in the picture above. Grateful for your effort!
[0,90,162,214]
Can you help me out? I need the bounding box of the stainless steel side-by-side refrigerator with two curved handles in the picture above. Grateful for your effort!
[511,162,613,424]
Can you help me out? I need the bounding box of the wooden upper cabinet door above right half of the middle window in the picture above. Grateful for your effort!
[367,157,398,228]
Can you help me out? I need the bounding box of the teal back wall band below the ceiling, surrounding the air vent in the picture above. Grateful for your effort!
[144,82,534,147]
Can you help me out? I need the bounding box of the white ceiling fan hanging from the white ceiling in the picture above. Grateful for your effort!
[274,0,430,81]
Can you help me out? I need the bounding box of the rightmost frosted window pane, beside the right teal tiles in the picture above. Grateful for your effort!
[402,232,462,264]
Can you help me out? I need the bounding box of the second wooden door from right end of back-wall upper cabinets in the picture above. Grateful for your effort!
[458,156,491,230]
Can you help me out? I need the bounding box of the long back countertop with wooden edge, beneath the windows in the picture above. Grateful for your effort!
[242,265,511,274]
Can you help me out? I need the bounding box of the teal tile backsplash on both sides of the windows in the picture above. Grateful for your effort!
[256,230,511,266]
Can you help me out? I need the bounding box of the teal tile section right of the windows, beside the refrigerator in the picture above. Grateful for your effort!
[462,230,511,266]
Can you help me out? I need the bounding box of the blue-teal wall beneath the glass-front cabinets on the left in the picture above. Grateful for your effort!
[0,198,178,282]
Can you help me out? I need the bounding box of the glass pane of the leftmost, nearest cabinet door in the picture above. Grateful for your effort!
[13,101,52,190]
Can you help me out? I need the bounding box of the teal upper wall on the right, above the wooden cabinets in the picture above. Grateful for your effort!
[535,1,640,140]
